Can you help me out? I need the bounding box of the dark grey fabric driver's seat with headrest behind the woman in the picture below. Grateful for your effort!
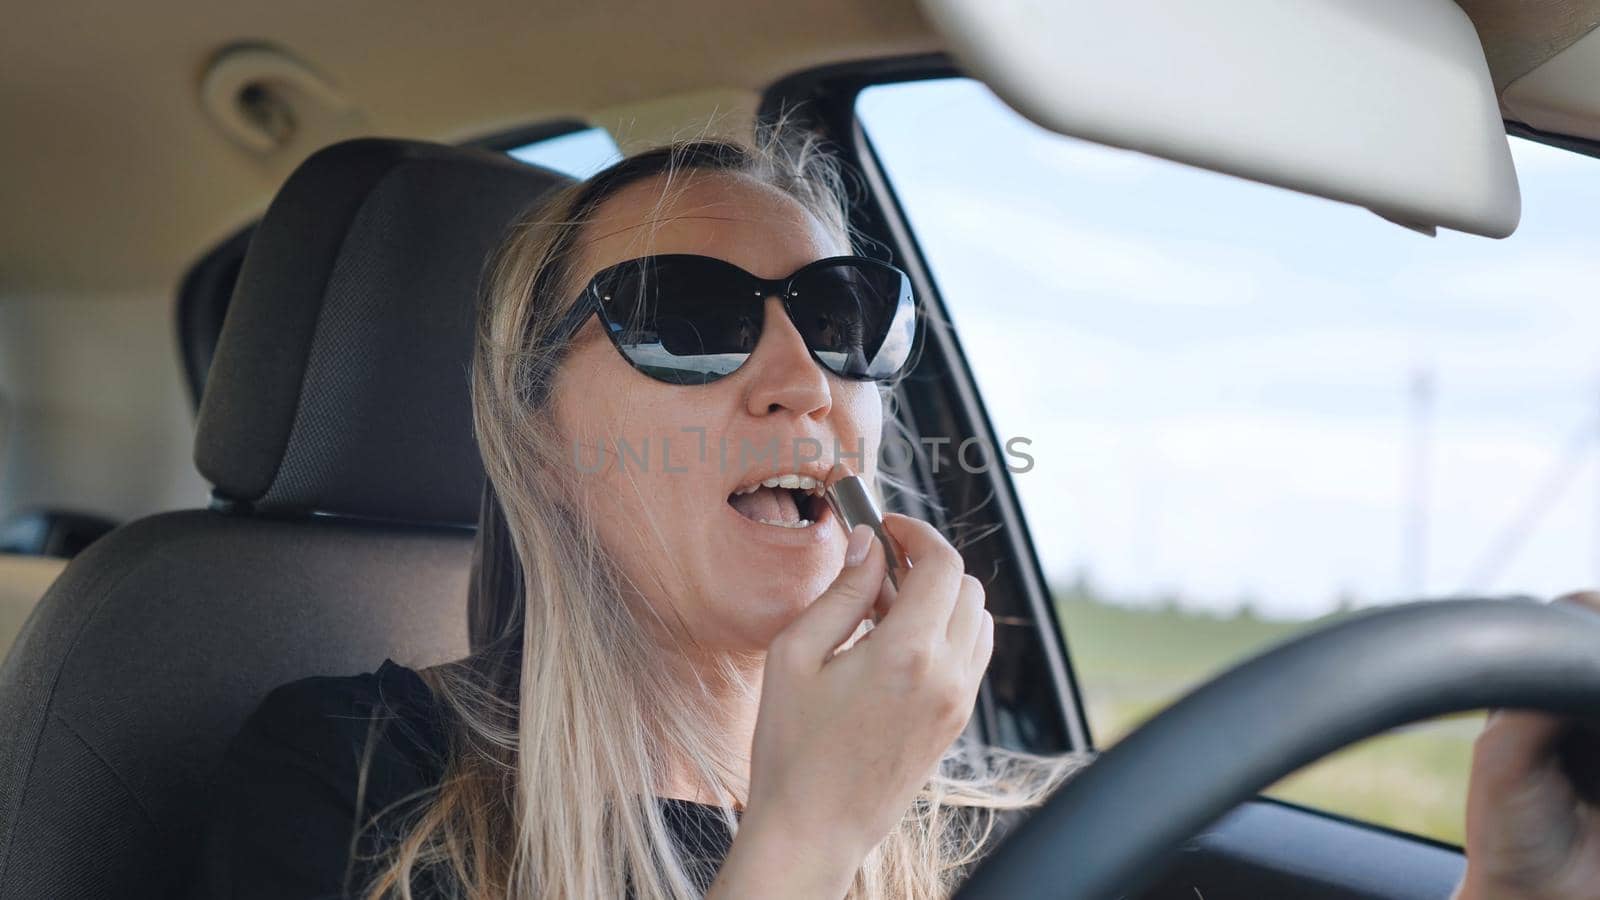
[0,139,568,900]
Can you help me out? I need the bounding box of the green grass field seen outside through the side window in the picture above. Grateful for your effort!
[1056,589,1483,844]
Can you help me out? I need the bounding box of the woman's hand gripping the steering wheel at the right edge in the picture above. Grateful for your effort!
[1456,593,1600,900]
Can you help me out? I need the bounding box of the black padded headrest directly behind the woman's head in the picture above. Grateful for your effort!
[195,139,571,525]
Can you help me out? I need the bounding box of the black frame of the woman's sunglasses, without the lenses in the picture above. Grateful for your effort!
[552,253,923,386]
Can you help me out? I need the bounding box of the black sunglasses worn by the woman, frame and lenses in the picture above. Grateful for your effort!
[555,253,918,384]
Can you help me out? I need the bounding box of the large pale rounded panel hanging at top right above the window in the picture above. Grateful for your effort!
[922,0,1522,237]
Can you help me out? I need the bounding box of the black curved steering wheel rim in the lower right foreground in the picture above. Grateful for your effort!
[955,599,1600,900]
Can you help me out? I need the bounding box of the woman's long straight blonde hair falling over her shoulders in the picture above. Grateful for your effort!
[352,115,1078,900]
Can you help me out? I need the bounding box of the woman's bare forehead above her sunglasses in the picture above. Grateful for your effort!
[574,171,850,283]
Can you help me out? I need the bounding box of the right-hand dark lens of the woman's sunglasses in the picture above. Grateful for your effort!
[789,261,917,380]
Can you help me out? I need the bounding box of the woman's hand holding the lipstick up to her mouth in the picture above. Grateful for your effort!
[741,512,994,887]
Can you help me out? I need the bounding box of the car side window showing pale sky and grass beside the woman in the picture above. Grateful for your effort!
[858,78,1600,842]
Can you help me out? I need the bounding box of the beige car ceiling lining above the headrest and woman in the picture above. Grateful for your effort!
[0,0,1600,301]
